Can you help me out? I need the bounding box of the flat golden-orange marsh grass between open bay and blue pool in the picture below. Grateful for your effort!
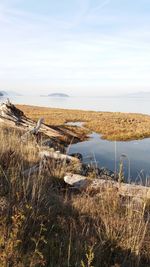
[18,105,150,141]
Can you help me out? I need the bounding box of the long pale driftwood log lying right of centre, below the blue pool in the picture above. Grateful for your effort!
[64,173,150,199]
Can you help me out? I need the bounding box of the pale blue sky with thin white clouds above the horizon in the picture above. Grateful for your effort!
[0,0,150,96]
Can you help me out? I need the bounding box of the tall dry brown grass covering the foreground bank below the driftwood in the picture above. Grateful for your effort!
[0,128,150,267]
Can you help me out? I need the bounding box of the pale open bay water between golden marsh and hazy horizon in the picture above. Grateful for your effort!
[1,96,150,114]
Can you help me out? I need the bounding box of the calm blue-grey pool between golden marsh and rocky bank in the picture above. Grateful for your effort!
[68,133,150,183]
